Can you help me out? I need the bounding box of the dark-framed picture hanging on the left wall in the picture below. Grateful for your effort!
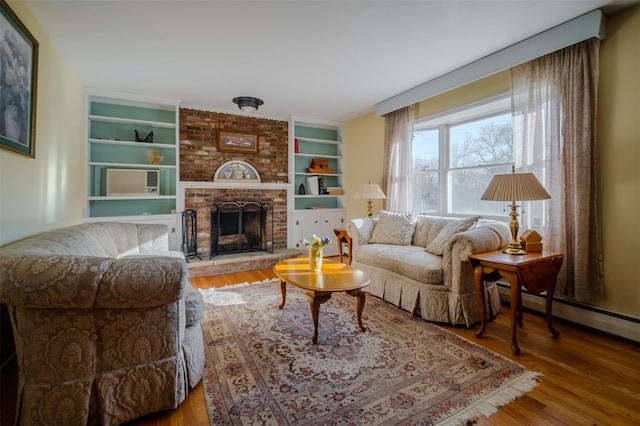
[0,0,38,158]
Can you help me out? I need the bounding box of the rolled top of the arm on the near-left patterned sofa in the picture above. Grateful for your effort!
[0,255,187,309]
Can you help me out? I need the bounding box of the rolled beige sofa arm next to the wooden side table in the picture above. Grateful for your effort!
[442,221,511,294]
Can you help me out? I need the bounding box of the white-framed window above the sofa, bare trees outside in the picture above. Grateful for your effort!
[412,95,514,219]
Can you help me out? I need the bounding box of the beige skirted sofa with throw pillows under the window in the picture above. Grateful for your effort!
[347,211,511,327]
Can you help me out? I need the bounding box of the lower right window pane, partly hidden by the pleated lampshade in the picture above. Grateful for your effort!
[447,166,511,216]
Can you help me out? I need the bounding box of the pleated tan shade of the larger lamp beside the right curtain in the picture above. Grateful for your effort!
[480,173,551,201]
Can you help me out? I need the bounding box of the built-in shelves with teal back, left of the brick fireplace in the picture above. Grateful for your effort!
[85,90,179,218]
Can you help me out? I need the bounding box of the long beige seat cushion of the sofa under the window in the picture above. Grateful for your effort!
[354,244,443,284]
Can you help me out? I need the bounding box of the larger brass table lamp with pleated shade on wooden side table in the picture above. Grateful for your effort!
[480,166,551,254]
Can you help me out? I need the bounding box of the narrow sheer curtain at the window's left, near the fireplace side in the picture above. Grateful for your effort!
[382,106,413,213]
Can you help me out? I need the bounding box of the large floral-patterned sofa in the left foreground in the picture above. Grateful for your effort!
[0,222,204,425]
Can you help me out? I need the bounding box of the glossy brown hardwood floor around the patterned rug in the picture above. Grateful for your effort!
[0,269,640,426]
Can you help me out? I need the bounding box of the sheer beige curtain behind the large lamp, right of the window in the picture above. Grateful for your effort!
[511,38,603,303]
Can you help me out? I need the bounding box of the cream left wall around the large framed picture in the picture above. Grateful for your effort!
[0,0,85,245]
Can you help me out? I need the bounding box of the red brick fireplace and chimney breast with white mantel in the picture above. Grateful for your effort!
[178,108,291,276]
